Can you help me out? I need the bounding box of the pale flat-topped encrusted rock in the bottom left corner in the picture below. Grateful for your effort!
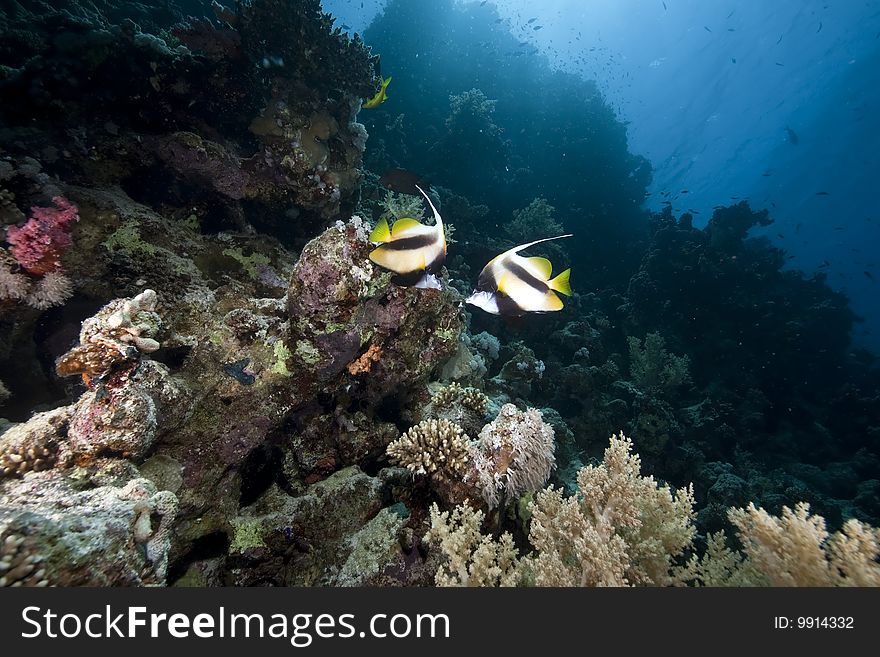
[0,465,177,586]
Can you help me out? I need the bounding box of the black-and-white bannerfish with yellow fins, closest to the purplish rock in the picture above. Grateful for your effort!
[370,185,446,289]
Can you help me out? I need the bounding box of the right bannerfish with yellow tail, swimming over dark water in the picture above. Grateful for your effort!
[465,235,571,317]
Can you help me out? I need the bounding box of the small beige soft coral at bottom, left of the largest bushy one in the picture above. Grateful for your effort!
[425,504,520,586]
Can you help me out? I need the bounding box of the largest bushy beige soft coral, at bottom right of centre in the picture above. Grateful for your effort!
[529,434,695,586]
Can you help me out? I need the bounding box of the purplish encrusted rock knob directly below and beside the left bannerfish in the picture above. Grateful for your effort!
[287,220,463,401]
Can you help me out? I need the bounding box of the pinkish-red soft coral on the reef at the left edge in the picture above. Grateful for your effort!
[6,196,79,276]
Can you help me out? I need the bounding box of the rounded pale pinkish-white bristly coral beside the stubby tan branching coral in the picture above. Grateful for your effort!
[474,404,556,508]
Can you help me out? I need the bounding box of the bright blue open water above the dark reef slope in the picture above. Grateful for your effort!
[324,0,880,352]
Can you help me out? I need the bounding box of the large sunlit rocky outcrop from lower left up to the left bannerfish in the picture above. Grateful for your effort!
[0,219,462,584]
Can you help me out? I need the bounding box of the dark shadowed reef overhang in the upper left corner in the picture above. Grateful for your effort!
[0,0,379,236]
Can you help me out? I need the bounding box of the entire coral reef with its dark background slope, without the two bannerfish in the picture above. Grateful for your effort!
[0,0,880,586]
